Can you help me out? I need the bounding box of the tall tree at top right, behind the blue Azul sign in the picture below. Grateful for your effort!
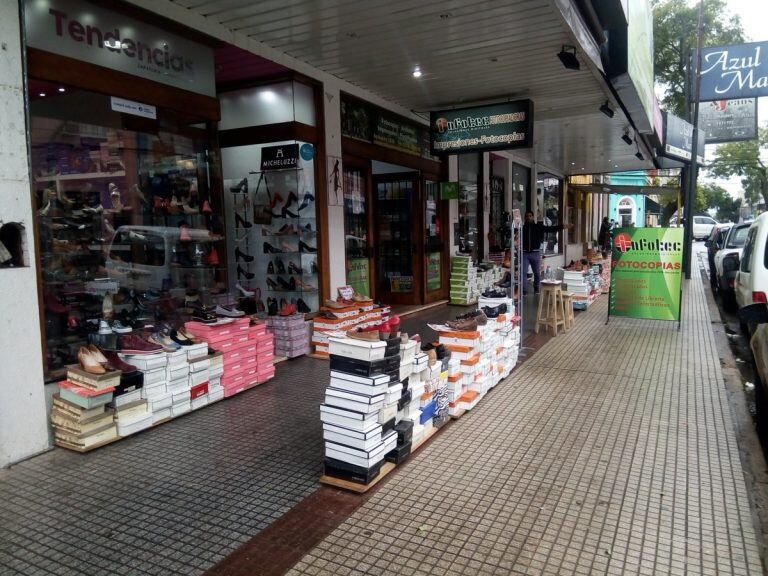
[653,0,744,119]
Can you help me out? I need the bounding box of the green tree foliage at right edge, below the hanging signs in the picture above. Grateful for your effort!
[707,127,768,206]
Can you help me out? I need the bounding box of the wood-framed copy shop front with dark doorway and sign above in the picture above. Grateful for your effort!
[338,94,449,304]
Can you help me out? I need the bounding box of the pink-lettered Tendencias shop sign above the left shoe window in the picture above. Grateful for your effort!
[24,0,216,96]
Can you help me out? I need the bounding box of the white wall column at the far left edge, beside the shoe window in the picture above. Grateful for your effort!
[0,1,50,468]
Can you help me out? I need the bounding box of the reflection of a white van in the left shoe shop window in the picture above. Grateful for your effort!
[105,226,222,291]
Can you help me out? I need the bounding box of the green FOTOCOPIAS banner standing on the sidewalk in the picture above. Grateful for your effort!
[609,228,683,321]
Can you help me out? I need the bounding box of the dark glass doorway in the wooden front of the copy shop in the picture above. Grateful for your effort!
[374,174,422,304]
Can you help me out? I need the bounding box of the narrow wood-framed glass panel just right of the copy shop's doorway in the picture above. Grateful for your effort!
[424,180,445,303]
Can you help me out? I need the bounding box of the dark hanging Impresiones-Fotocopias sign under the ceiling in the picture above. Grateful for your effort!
[430,100,533,154]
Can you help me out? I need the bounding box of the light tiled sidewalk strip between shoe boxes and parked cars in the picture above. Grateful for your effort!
[290,275,762,576]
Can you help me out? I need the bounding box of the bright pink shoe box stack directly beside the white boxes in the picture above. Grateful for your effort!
[184,317,275,398]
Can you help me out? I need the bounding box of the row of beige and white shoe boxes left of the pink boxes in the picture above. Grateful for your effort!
[51,343,225,452]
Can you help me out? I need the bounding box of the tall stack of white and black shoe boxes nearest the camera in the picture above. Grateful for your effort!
[320,337,402,484]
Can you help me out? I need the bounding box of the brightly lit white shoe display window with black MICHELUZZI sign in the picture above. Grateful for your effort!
[221,140,320,316]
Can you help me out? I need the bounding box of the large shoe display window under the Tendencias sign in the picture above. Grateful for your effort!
[30,80,222,379]
